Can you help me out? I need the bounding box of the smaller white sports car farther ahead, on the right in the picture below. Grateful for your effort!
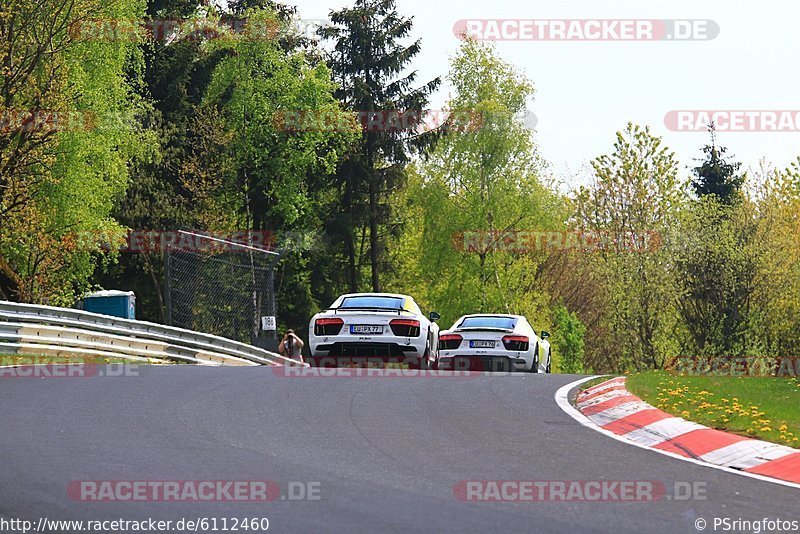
[437,315,551,373]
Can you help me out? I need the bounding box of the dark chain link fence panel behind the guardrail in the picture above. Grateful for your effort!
[165,232,280,348]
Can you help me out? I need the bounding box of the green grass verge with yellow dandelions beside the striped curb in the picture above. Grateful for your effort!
[627,371,800,448]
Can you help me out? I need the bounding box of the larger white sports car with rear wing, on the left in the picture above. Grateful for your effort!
[308,293,440,369]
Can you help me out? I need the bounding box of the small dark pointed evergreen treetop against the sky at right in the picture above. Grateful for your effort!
[692,123,744,205]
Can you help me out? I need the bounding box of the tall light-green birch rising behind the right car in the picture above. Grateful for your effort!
[393,40,565,324]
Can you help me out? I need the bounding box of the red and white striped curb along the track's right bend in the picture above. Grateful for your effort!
[556,377,800,488]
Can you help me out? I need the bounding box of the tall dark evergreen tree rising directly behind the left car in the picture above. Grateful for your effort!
[319,0,441,291]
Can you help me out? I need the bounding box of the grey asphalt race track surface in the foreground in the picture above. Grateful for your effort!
[0,366,800,533]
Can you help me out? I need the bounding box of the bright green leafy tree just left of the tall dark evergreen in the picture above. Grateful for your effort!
[198,9,358,336]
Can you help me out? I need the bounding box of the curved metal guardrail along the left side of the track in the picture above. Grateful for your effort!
[0,301,306,366]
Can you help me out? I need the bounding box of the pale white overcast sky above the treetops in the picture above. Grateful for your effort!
[287,0,800,191]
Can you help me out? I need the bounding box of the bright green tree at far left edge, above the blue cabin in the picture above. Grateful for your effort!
[0,0,154,304]
